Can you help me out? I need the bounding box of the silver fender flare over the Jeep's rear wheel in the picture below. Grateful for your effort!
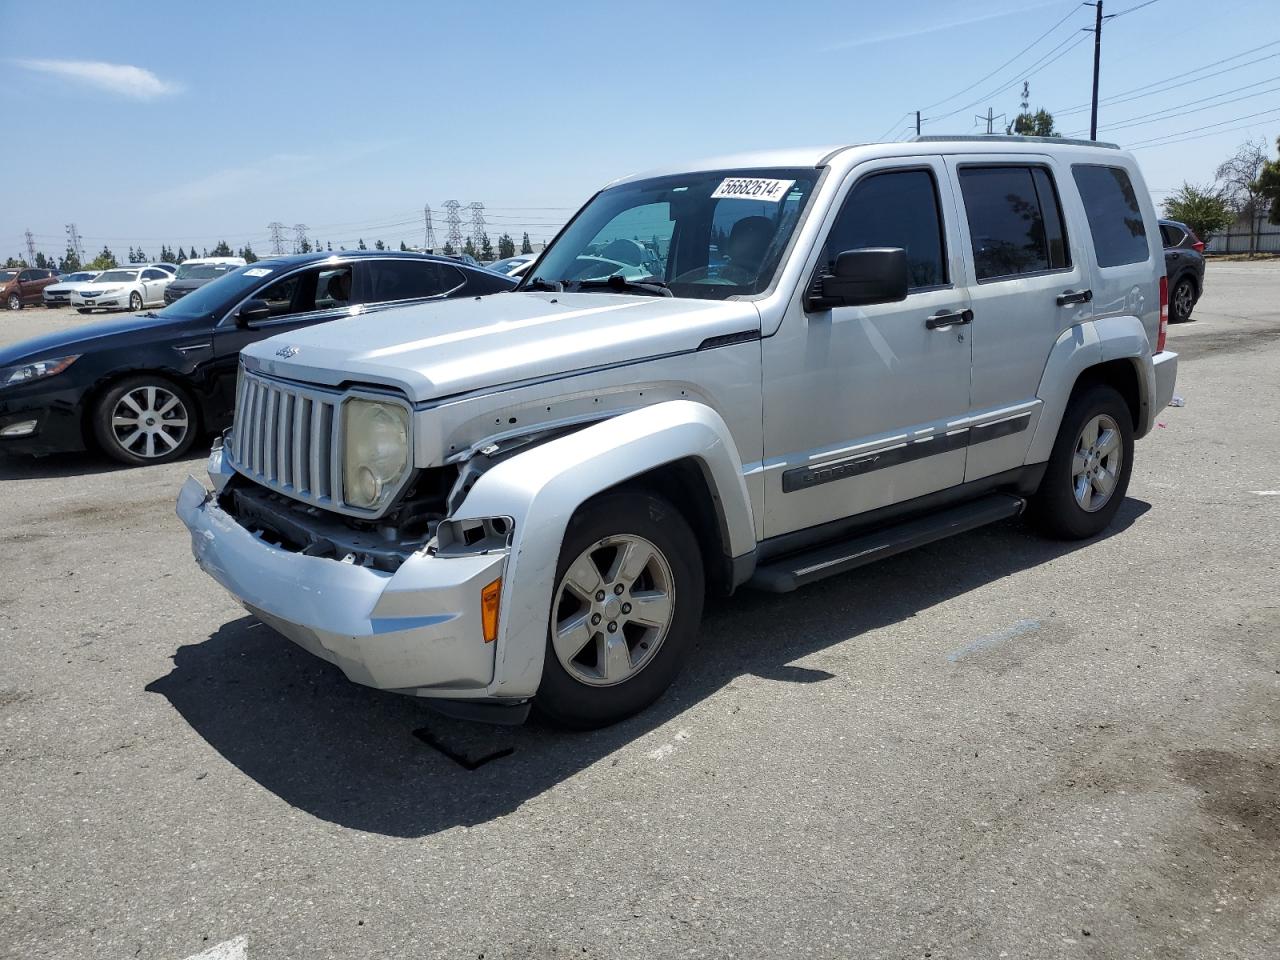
[1025,316,1156,463]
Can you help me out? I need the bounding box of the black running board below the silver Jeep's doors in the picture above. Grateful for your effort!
[746,493,1027,594]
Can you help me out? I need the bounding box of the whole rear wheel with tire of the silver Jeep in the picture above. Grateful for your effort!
[1030,384,1133,540]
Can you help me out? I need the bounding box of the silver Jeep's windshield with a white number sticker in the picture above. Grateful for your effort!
[522,168,818,300]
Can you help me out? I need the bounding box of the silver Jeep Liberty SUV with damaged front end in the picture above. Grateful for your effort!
[178,137,1178,727]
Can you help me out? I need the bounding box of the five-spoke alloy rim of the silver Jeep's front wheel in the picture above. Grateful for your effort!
[552,534,676,686]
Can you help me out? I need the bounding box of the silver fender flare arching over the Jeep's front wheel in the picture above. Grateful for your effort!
[453,401,755,698]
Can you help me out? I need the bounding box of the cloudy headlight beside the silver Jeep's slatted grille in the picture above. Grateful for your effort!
[342,399,408,509]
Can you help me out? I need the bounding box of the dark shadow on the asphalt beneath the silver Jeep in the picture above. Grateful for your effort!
[146,498,1151,837]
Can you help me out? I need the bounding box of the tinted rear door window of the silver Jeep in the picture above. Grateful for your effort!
[960,166,1071,282]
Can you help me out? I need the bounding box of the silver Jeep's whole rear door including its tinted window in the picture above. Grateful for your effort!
[947,154,1092,481]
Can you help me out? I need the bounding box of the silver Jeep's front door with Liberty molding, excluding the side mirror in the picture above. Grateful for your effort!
[763,157,970,536]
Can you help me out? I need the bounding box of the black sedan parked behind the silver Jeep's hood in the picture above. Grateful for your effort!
[0,251,516,463]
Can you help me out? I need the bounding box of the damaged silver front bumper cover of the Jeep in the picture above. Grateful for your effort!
[178,471,507,698]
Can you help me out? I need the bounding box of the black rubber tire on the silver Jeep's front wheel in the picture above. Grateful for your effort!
[534,489,705,730]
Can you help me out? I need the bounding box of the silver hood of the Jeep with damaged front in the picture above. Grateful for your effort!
[242,292,760,403]
